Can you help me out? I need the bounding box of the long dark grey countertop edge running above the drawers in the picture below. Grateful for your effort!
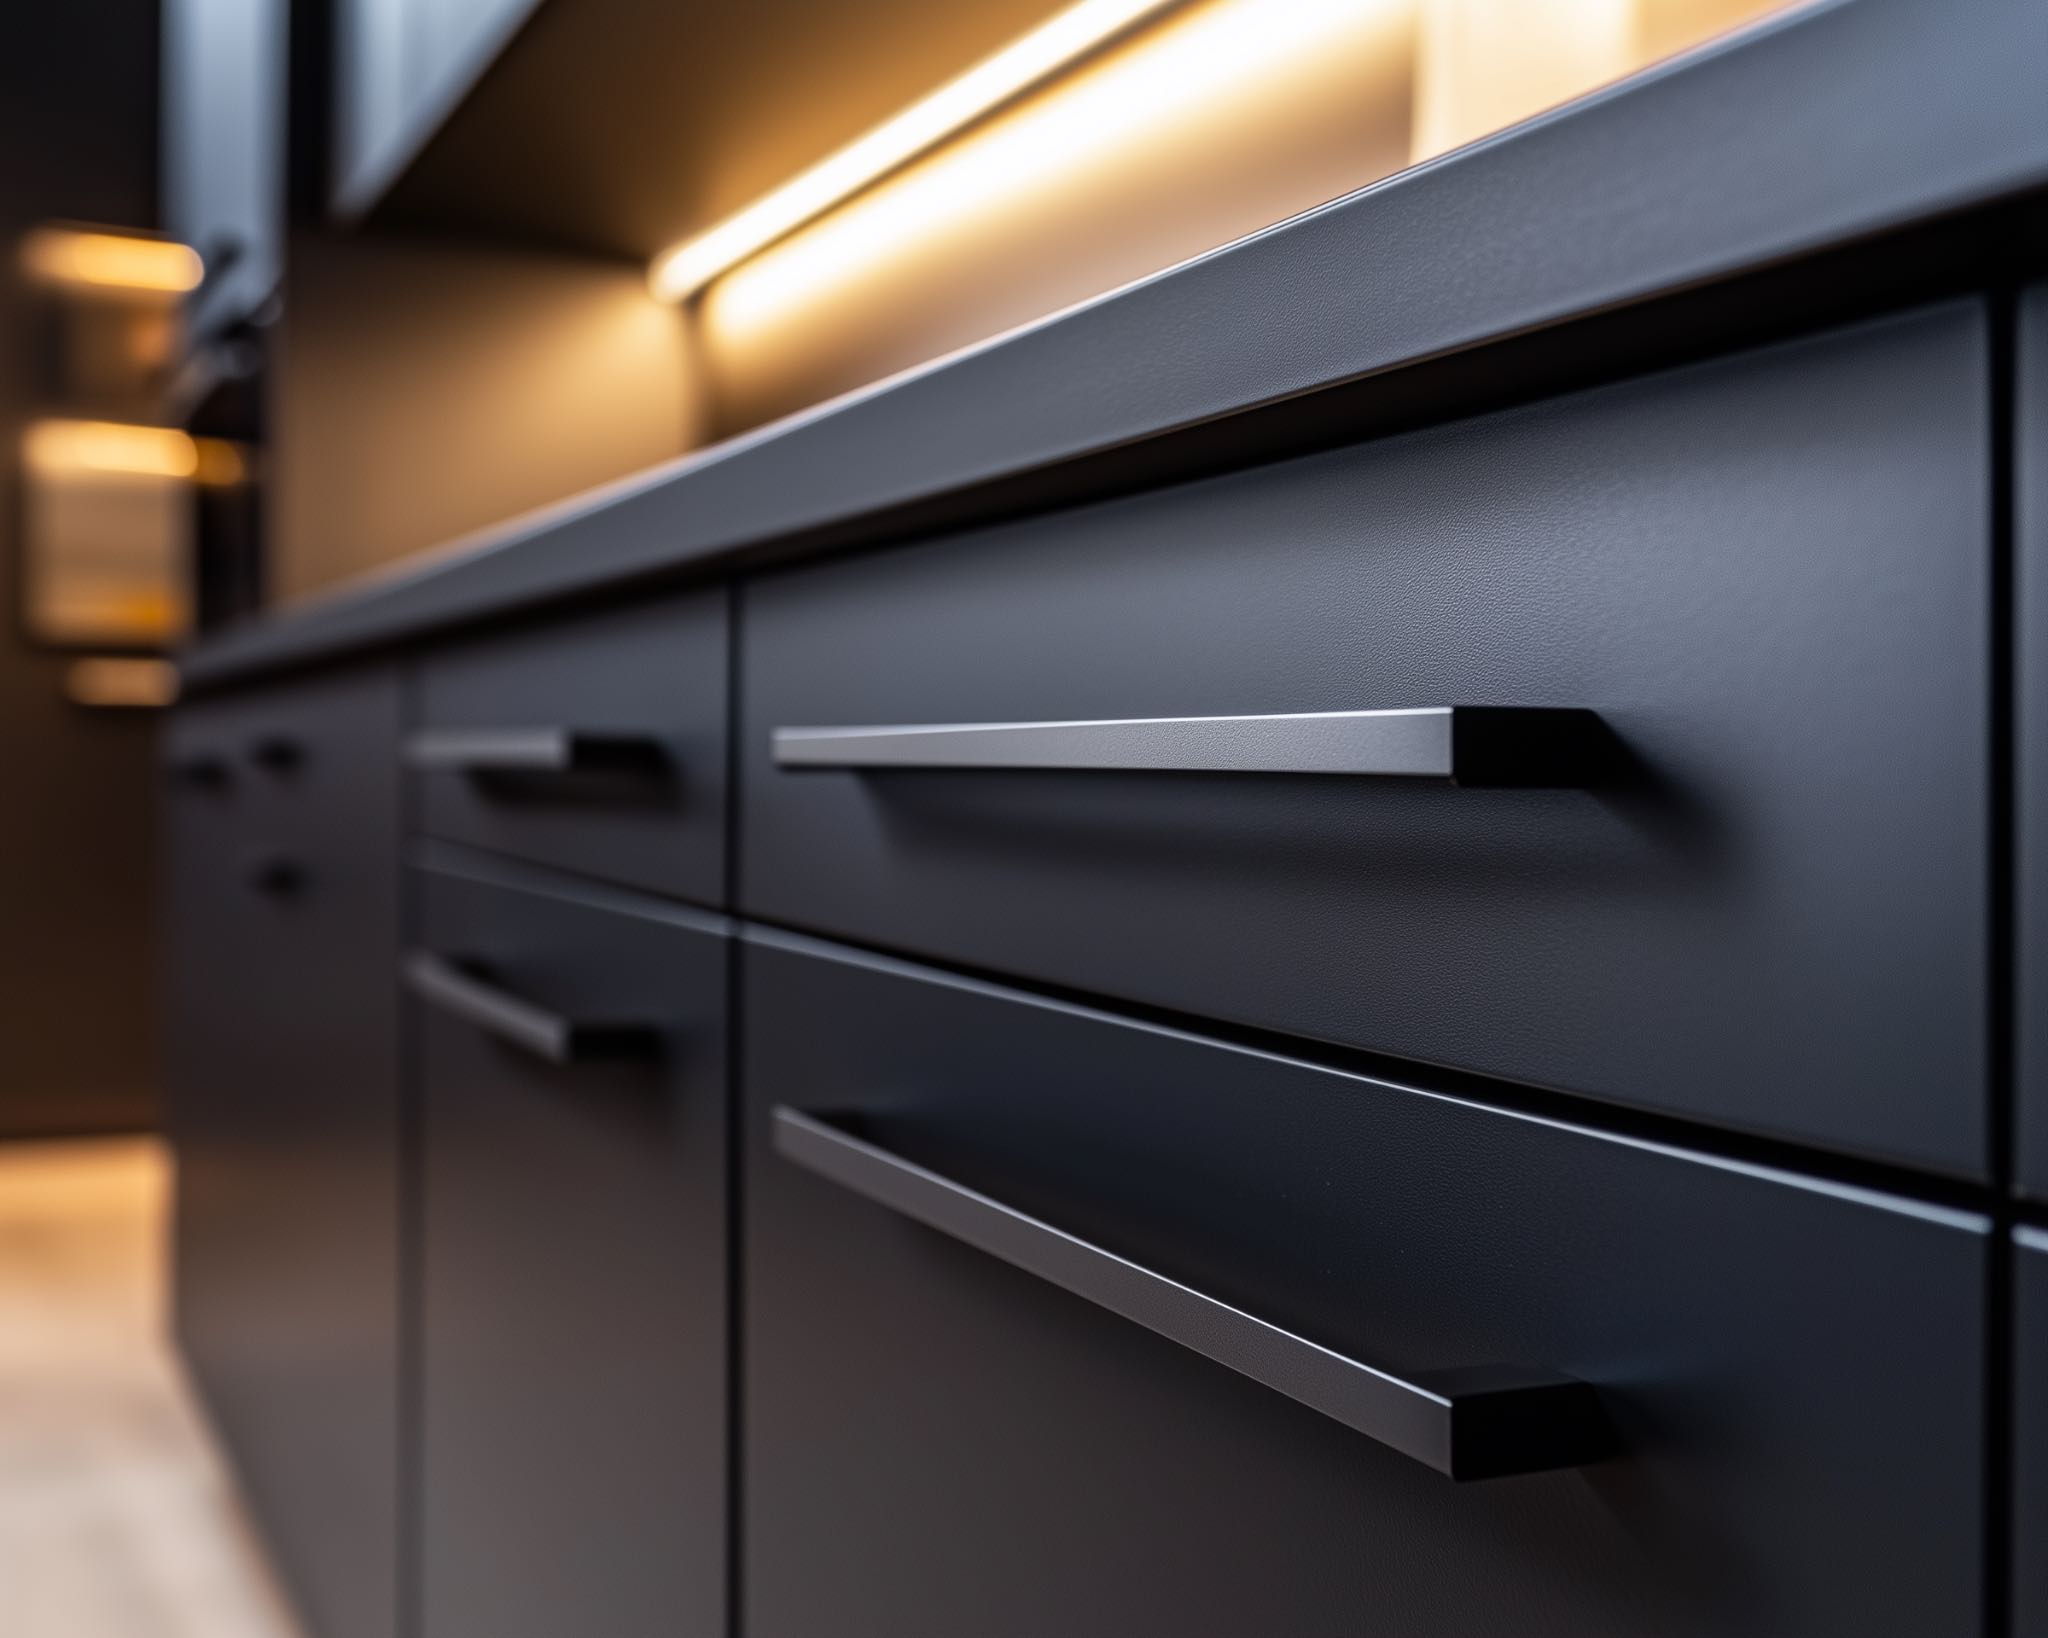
[182,0,2048,690]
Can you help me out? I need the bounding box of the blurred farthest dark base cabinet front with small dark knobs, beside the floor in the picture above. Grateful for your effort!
[166,670,399,1638]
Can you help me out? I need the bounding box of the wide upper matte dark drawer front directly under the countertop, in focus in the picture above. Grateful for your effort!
[741,303,1989,1173]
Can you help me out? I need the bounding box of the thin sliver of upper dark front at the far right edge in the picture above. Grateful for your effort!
[2013,285,2048,1200]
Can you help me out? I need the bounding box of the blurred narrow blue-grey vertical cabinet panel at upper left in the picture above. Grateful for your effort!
[164,0,287,338]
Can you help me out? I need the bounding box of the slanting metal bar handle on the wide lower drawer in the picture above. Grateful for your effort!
[774,1106,1612,1478]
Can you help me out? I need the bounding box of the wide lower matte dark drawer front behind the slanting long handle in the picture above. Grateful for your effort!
[741,934,1987,1638]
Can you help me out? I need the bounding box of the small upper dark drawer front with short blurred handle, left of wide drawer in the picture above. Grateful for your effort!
[410,590,727,905]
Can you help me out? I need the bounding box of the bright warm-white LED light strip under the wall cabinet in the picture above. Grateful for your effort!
[649,0,1186,301]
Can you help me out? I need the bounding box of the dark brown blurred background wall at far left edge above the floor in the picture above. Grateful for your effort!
[0,0,158,1136]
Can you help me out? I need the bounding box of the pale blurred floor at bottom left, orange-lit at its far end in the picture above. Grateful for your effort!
[0,1138,297,1638]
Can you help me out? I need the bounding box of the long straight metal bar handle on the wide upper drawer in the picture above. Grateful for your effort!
[774,704,1606,786]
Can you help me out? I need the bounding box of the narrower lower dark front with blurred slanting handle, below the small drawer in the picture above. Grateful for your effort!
[408,858,729,1638]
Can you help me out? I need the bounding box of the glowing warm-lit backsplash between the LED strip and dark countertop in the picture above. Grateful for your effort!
[678,0,1796,432]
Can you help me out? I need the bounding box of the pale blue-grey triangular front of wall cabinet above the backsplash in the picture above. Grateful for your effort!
[334,0,537,215]
